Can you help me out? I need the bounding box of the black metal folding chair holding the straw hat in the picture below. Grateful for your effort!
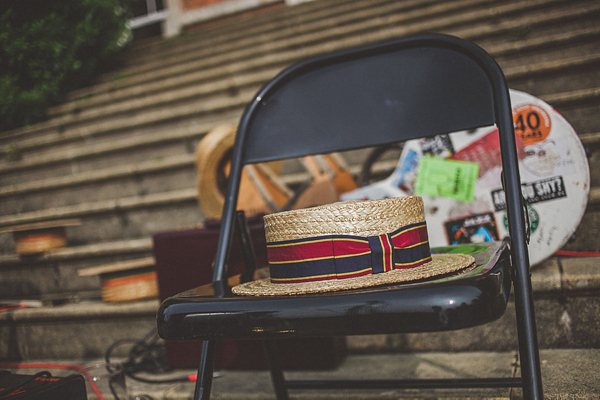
[158,34,542,399]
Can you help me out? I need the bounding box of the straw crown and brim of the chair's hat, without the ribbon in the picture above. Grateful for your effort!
[232,196,475,296]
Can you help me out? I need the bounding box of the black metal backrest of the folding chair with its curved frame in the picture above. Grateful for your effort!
[214,34,528,280]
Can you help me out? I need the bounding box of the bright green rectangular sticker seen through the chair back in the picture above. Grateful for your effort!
[415,156,479,202]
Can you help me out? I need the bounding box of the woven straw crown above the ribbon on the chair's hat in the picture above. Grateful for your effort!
[264,196,425,243]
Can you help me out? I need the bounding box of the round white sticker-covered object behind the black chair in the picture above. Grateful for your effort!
[342,90,590,265]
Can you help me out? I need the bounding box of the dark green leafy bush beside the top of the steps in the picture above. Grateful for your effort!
[0,0,125,131]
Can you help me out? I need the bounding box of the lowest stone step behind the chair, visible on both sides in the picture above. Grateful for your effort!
[0,253,600,360]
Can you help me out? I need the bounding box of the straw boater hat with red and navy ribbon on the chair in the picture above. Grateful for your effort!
[232,196,475,296]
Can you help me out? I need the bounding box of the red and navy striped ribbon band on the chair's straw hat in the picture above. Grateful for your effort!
[267,222,431,283]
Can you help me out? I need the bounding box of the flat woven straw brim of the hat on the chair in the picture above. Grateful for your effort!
[232,254,475,296]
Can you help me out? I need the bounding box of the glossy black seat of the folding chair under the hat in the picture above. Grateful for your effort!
[157,242,511,340]
